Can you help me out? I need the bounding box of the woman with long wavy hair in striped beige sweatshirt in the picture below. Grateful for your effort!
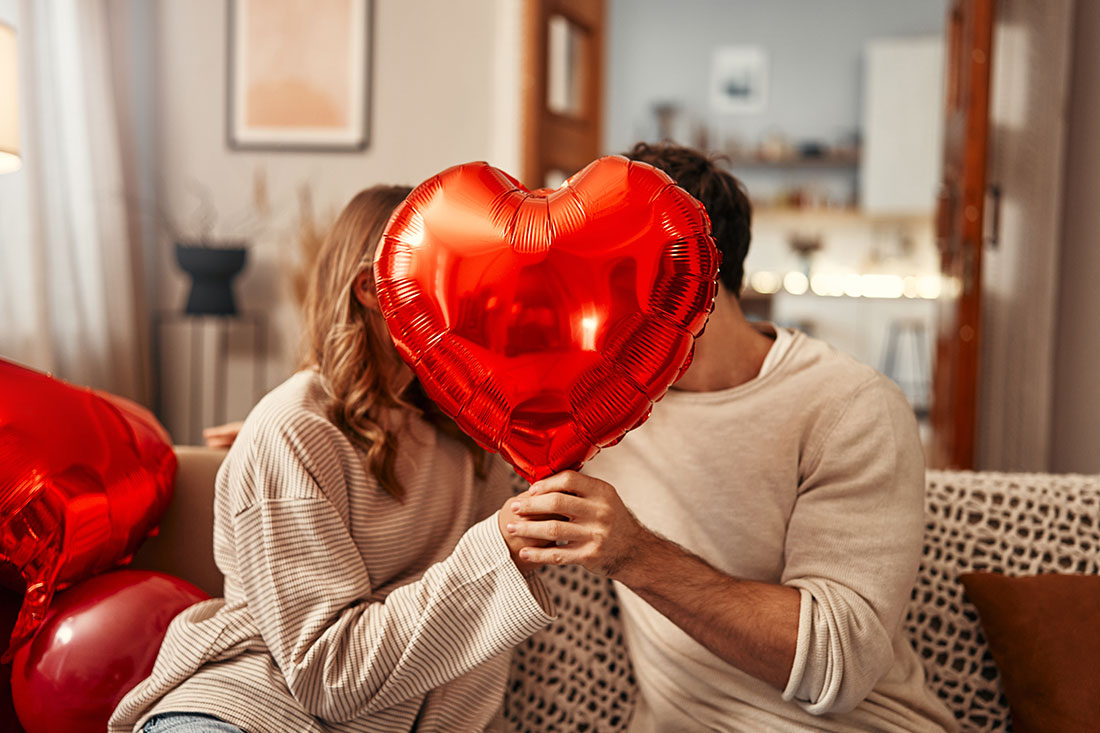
[110,186,550,733]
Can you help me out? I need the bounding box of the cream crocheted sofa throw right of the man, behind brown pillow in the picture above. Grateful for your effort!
[905,471,1100,731]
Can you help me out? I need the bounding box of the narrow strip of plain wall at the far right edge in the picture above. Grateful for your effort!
[1051,0,1100,473]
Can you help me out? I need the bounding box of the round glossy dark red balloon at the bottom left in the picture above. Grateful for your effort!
[11,570,208,733]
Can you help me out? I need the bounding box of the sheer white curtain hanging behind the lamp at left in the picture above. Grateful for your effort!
[0,0,150,403]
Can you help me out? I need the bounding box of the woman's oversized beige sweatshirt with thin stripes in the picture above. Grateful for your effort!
[109,372,551,733]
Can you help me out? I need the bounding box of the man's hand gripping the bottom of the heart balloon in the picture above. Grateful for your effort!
[502,471,653,580]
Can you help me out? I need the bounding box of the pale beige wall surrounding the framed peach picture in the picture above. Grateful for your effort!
[148,0,520,440]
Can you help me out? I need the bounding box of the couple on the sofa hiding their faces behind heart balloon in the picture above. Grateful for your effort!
[110,144,955,733]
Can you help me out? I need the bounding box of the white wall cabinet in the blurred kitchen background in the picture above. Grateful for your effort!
[859,37,944,215]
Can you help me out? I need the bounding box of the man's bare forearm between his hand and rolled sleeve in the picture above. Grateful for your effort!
[614,535,801,690]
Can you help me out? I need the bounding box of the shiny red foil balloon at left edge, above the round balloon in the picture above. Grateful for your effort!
[0,360,176,660]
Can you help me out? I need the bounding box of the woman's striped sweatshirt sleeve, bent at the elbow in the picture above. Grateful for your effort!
[232,411,551,722]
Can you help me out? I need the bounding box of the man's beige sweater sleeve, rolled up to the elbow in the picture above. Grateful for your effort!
[782,375,924,714]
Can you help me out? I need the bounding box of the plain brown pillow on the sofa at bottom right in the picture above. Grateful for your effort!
[959,572,1100,733]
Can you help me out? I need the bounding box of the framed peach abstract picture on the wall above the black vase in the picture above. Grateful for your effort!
[227,0,371,151]
